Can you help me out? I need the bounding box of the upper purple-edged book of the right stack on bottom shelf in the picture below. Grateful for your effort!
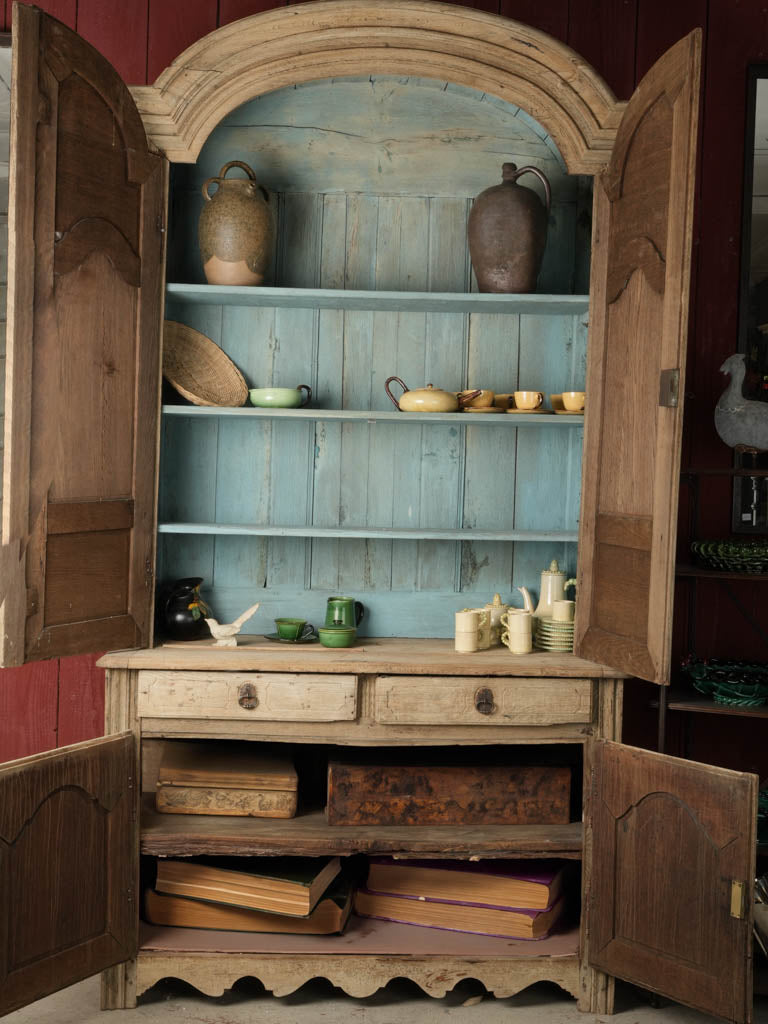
[368,857,563,911]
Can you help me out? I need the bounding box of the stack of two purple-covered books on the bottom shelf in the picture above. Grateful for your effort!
[354,858,564,939]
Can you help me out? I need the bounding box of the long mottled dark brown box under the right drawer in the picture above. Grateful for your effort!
[326,761,570,825]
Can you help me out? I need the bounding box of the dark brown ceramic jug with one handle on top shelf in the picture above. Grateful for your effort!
[468,164,551,293]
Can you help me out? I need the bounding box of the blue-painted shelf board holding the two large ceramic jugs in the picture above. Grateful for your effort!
[166,283,589,315]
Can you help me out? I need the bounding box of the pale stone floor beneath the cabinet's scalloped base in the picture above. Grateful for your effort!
[4,978,768,1024]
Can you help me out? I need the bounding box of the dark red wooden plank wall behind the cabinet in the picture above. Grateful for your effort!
[0,0,768,761]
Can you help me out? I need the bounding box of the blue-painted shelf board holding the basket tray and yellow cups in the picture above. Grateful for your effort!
[163,406,584,427]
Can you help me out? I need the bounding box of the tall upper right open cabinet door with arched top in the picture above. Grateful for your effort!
[574,30,701,683]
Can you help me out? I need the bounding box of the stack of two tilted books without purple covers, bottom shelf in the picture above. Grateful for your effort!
[144,857,352,935]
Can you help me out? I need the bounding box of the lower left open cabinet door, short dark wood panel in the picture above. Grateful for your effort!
[0,732,138,1016]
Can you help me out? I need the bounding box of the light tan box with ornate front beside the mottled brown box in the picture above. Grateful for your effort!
[156,740,298,818]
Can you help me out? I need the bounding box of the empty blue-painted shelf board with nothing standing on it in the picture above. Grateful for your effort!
[158,522,579,544]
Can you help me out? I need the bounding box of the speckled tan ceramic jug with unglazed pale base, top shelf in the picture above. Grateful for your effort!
[198,160,274,285]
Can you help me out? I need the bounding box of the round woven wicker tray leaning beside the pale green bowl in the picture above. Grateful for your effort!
[163,321,248,406]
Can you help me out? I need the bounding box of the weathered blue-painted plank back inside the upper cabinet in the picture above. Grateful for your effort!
[159,79,590,636]
